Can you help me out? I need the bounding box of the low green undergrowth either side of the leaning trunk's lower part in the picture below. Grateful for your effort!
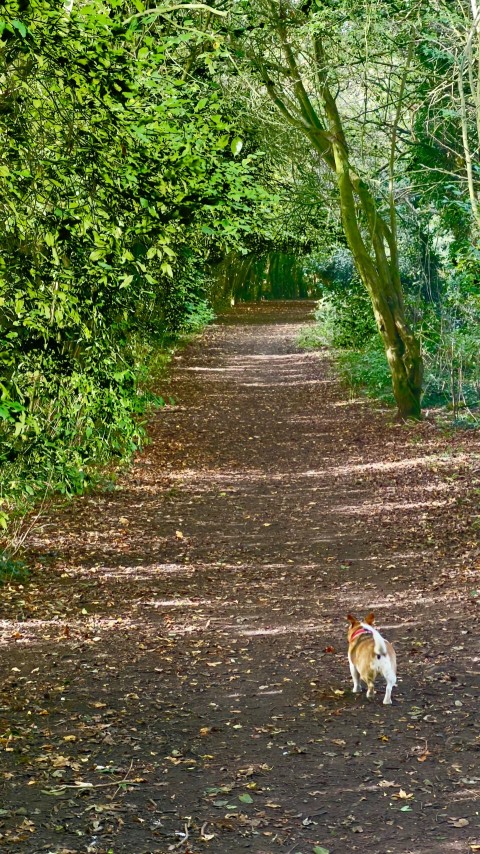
[298,247,480,419]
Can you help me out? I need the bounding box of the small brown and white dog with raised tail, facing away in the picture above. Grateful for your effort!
[347,614,397,705]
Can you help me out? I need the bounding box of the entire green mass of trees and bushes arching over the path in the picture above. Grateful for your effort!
[0,0,480,519]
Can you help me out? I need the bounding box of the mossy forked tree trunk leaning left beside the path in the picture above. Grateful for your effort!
[254,5,423,418]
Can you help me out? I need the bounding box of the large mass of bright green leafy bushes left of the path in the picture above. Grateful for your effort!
[0,0,275,523]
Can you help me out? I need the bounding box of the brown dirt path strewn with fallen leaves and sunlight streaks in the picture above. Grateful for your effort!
[0,303,480,854]
